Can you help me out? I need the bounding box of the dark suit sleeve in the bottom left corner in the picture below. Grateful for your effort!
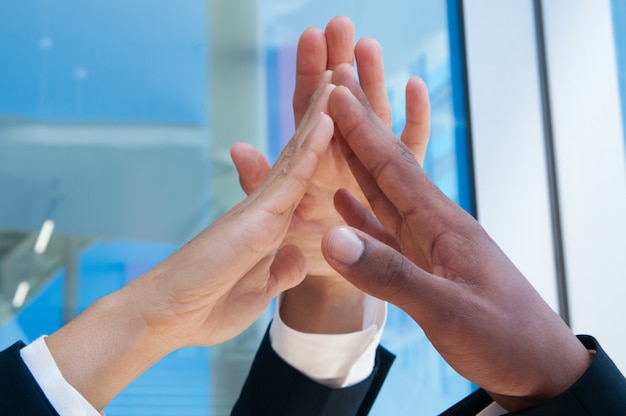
[0,342,58,416]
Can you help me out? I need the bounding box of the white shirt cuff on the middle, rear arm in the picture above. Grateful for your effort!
[270,295,387,388]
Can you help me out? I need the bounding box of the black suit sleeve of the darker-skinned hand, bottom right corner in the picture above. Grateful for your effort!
[442,335,626,416]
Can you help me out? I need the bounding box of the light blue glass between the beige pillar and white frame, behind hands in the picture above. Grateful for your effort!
[263,0,473,415]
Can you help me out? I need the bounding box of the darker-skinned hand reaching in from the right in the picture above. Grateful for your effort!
[323,67,591,410]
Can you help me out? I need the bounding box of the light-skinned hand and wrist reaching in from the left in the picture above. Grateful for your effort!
[46,73,334,409]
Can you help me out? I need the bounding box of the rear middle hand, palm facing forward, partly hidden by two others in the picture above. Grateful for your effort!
[234,17,430,333]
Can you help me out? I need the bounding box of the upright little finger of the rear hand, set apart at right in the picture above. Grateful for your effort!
[401,78,430,165]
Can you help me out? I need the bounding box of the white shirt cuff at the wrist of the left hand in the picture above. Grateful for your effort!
[20,336,103,416]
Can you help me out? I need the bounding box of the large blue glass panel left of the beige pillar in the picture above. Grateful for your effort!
[0,0,210,415]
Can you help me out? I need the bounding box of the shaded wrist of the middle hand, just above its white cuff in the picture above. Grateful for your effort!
[280,276,365,334]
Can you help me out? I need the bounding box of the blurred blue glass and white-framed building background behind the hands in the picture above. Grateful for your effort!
[0,0,626,416]
